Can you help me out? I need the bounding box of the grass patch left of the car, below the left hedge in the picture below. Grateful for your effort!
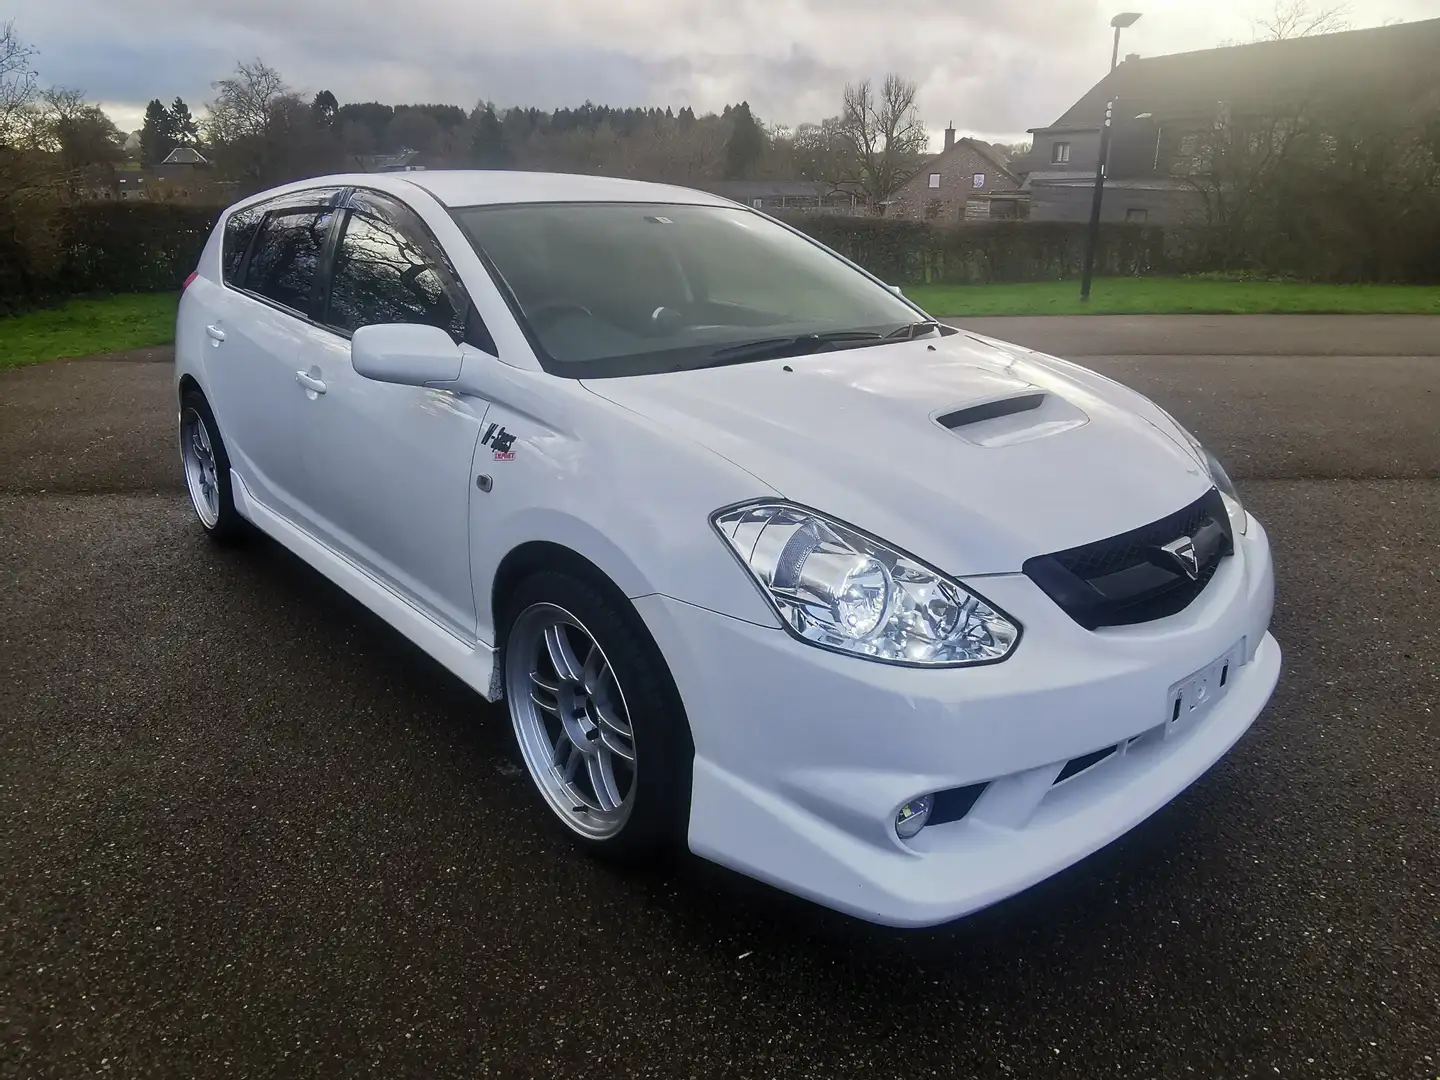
[0,292,179,369]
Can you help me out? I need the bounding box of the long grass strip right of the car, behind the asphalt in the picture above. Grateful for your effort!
[904,278,1440,315]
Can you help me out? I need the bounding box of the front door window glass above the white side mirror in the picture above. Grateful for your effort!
[325,196,469,341]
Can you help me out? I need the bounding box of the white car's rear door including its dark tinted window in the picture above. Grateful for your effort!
[204,187,341,520]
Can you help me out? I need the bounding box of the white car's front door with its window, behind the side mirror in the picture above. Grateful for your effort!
[283,192,488,642]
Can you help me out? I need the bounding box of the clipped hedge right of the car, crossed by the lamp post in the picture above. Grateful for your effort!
[786,215,1179,285]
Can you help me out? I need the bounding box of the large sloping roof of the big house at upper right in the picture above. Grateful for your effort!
[1031,19,1440,132]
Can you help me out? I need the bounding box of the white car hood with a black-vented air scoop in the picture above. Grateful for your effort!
[586,333,1210,575]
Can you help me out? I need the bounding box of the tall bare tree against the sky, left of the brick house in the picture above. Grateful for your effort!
[840,73,930,210]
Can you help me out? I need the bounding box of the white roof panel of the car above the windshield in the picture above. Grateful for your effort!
[238,168,734,207]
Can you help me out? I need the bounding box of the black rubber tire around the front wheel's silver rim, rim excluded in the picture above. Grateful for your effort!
[498,572,694,863]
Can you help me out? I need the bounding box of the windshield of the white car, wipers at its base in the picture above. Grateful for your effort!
[455,203,924,379]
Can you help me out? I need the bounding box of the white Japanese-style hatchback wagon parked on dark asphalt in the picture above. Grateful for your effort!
[176,171,1280,926]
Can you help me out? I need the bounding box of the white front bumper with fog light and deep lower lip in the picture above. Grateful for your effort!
[636,518,1280,926]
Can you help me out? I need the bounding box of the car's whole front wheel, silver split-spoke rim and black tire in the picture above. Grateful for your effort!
[503,572,694,864]
